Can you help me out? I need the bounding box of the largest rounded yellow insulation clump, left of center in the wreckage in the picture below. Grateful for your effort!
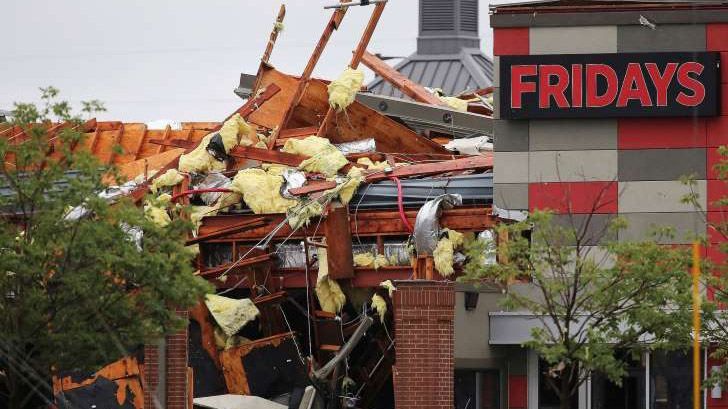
[230,168,298,214]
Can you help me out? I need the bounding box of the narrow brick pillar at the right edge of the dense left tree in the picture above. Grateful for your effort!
[165,311,192,409]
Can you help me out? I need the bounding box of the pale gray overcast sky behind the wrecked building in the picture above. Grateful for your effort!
[0,0,500,122]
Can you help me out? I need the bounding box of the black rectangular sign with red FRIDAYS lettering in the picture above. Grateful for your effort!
[499,52,728,119]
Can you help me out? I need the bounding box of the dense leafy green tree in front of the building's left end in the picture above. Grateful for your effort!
[0,88,210,408]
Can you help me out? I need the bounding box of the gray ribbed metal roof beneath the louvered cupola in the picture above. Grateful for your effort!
[367,48,493,98]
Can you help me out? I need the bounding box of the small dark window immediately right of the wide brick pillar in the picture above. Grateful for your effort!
[455,370,500,409]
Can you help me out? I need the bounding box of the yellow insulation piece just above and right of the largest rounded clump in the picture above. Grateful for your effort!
[283,136,349,177]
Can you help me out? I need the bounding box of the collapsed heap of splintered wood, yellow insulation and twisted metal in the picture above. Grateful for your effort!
[45,2,495,408]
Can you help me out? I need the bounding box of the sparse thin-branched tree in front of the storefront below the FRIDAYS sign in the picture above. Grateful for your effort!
[464,211,691,409]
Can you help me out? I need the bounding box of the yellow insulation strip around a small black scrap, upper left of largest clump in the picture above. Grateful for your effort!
[178,114,252,173]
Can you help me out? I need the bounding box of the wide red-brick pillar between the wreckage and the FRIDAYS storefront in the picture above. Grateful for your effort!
[393,280,455,409]
